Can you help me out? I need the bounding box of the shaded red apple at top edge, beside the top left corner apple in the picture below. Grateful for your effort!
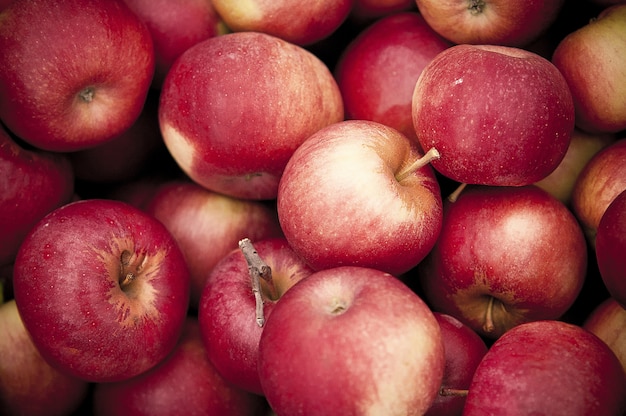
[124,0,225,89]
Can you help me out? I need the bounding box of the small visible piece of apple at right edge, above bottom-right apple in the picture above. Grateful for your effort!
[582,297,626,373]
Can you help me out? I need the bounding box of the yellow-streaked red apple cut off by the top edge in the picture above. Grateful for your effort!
[211,0,353,46]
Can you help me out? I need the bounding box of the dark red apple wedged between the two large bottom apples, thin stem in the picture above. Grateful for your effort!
[426,312,487,416]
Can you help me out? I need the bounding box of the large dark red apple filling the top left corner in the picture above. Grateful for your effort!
[0,0,154,152]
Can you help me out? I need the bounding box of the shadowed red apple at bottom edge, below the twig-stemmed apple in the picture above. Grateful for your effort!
[93,316,263,416]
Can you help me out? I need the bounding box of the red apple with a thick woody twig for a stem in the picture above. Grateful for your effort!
[198,238,313,395]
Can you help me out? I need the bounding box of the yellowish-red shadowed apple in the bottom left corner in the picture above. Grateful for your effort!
[0,300,88,416]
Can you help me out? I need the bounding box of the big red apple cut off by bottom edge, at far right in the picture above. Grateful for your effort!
[463,320,626,416]
